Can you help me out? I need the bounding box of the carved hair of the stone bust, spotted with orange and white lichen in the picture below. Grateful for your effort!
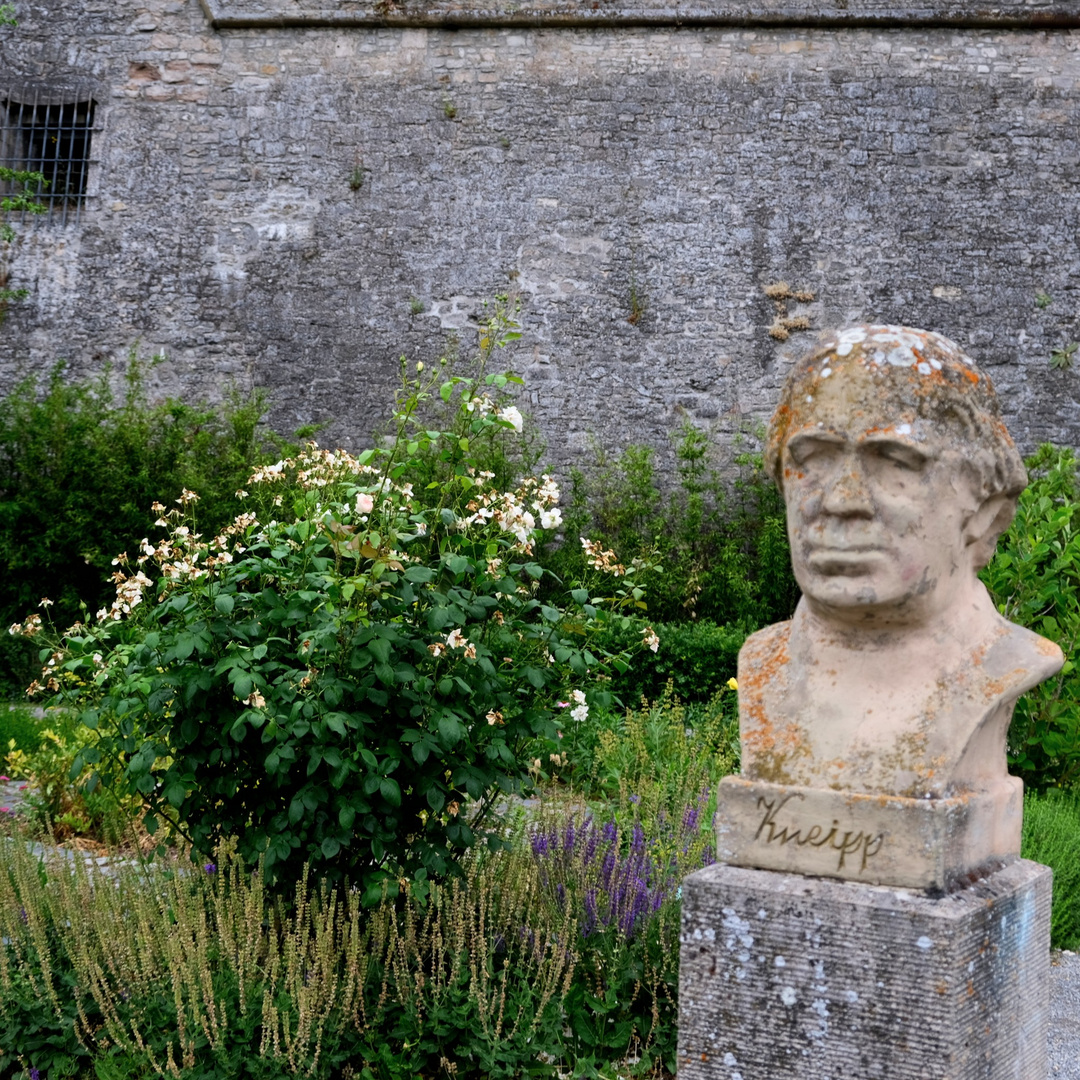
[765,325,1027,507]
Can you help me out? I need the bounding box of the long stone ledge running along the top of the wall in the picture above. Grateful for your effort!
[200,0,1080,30]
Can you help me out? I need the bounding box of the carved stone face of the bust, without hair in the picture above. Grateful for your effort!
[782,390,975,625]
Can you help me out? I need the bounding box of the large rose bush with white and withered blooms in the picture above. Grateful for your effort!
[11,306,656,900]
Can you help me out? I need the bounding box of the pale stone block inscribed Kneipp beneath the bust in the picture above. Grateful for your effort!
[716,777,1024,892]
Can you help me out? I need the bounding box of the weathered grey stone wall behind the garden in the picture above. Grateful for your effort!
[0,0,1080,464]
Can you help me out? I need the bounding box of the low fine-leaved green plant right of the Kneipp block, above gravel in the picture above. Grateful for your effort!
[1021,788,1080,951]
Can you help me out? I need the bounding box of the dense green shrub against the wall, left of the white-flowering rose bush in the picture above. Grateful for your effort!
[0,351,295,694]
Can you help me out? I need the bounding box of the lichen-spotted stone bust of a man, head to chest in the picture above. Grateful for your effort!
[739,325,1063,807]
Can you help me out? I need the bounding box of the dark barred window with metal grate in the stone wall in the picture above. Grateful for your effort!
[0,85,95,224]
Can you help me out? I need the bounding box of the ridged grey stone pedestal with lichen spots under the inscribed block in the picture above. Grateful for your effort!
[678,860,1051,1080]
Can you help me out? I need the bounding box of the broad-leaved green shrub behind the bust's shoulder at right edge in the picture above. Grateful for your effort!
[982,445,1080,788]
